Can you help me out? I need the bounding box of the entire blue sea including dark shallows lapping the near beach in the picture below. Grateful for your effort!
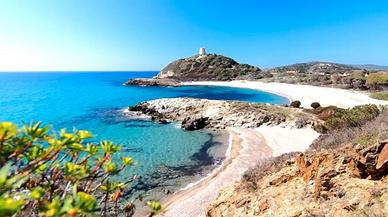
[0,71,288,205]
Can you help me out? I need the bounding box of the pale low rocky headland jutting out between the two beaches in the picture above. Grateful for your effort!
[129,98,317,130]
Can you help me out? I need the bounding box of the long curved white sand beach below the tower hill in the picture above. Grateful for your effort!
[182,81,388,108]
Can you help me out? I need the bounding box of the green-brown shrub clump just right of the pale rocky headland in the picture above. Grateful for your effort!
[315,105,380,132]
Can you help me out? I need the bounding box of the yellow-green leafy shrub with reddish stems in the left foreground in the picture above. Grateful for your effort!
[0,122,150,217]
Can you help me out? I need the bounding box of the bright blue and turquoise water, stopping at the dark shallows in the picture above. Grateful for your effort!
[0,72,288,180]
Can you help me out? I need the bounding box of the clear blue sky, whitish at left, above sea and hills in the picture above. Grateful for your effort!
[0,0,388,71]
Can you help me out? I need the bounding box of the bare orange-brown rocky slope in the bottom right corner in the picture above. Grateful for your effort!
[207,141,388,217]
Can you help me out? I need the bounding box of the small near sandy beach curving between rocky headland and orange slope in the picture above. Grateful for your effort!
[158,127,318,217]
